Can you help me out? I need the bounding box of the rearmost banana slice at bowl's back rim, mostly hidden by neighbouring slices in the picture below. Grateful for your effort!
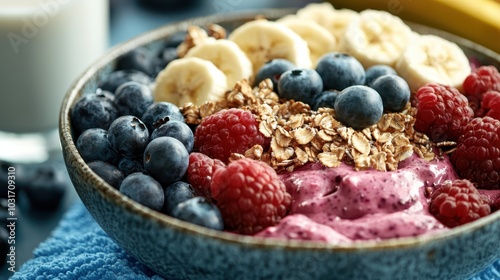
[296,2,359,47]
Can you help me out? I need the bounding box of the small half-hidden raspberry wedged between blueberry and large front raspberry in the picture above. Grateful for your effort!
[187,152,226,199]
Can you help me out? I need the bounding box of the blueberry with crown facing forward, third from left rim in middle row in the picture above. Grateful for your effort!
[108,115,149,158]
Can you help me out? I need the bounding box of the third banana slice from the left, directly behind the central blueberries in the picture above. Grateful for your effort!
[229,19,312,73]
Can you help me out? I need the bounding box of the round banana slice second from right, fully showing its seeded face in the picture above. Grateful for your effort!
[341,10,413,68]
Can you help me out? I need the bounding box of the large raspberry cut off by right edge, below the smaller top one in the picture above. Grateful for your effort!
[450,117,500,189]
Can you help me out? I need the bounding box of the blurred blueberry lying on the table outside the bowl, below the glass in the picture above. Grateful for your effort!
[25,162,69,210]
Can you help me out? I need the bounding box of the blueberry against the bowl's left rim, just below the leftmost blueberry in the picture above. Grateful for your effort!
[76,128,120,164]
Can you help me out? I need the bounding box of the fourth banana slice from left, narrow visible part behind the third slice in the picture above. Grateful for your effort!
[276,15,336,67]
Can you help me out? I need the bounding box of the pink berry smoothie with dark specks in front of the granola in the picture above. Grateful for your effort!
[257,155,458,244]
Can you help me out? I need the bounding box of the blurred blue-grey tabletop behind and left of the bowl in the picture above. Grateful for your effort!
[0,0,319,279]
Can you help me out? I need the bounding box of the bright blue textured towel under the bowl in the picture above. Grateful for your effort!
[11,201,500,280]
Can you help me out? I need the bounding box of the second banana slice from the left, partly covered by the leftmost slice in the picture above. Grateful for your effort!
[185,38,253,89]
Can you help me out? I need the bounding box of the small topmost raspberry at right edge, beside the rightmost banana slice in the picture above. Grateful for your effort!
[462,66,500,100]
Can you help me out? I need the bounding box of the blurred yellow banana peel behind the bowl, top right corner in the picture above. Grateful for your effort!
[329,0,500,54]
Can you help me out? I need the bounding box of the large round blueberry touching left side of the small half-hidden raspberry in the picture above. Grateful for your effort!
[144,136,189,186]
